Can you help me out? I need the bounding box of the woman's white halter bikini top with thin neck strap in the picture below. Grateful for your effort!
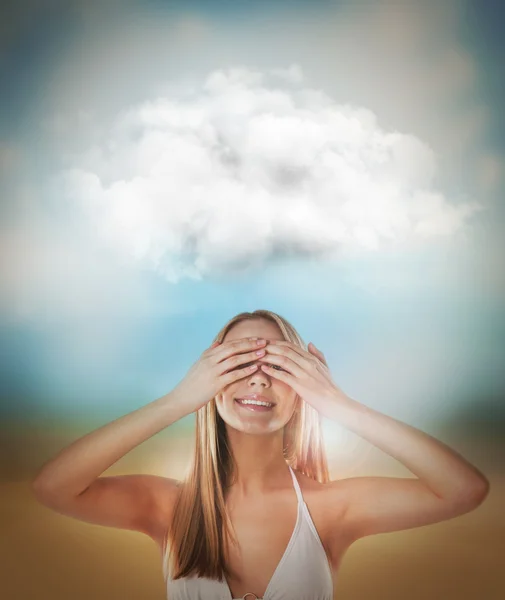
[163,467,333,600]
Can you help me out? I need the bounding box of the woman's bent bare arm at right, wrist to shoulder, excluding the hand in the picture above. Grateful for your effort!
[322,397,489,539]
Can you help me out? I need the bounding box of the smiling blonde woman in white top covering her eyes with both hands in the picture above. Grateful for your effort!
[34,310,489,600]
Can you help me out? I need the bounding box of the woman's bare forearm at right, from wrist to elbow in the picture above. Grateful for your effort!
[329,397,489,502]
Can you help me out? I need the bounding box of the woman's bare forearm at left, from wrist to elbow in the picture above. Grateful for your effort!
[32,393,185,496]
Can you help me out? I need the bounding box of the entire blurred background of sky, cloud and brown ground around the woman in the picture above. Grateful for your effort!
[0,0,505,600]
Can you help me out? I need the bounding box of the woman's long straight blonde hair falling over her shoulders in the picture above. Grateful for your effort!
[164,310,329,581]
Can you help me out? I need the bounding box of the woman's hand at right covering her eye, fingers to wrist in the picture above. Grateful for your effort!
[258,340,347,415]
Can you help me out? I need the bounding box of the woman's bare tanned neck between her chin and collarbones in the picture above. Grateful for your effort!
[224,428,289,498]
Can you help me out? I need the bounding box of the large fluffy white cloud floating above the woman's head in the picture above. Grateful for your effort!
[59,65,480,282]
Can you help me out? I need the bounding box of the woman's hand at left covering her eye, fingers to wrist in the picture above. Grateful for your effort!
[171,338,266,414]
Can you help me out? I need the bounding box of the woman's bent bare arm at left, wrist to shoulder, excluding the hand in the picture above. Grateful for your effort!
[32,393,187,539]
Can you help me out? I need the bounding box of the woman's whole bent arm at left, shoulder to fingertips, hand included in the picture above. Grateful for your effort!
[32,338,265,542]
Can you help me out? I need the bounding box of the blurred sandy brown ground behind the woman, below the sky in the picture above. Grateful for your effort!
[0,424,505,600]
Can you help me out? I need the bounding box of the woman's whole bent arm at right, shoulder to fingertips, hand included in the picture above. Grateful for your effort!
[250,340,489,540]
